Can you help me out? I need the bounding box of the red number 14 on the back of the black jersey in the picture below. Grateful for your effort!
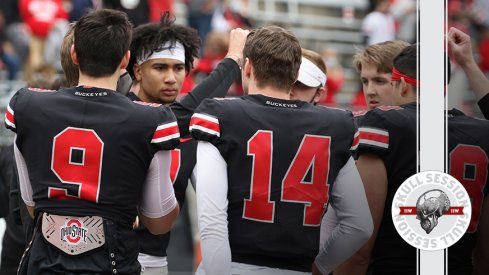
[243,130,331,226]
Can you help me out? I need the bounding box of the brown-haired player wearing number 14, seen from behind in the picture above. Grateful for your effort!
[190,26,372,275]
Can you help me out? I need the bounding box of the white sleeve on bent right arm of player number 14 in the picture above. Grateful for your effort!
[315,157,373,274]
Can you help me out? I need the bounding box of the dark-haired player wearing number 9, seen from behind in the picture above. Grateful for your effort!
[5,10,179,274]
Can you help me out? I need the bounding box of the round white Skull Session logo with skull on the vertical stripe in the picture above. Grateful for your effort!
[391,171,472,250]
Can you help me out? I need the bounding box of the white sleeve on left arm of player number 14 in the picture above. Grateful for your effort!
[193,141,231,275]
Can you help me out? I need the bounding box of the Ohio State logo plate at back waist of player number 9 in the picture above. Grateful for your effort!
[42,213,105,255]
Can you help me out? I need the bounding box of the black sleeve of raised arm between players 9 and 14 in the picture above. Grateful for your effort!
[170,58,241,137]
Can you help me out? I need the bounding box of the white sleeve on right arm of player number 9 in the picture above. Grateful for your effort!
[139,151,177,219]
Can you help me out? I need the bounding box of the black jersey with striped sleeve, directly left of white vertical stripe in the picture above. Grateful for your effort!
[356,103,417,274]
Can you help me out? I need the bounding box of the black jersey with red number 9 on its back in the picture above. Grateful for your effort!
[5,87,179,227]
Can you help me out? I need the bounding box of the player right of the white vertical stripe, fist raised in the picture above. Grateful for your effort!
[447,28,489,275]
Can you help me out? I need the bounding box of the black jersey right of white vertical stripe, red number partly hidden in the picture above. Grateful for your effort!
[447,109,489,275]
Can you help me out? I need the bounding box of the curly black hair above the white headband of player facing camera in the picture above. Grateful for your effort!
[127,12,200,79]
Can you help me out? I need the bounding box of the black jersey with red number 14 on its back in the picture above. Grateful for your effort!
[190,95,355,272]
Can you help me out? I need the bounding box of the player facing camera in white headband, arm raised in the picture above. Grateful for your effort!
[128,13,248,274]
